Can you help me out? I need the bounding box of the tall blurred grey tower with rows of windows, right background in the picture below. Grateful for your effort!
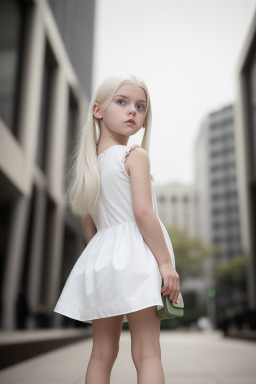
[195,105,242,260]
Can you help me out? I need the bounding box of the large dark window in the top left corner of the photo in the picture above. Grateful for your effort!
[0,0,28,137]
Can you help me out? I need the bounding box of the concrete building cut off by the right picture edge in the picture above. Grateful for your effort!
[236,12,256,312]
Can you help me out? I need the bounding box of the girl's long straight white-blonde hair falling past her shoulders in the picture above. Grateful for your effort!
[66,74,152,218]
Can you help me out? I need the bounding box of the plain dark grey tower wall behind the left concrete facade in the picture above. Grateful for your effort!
[48,0,95,98]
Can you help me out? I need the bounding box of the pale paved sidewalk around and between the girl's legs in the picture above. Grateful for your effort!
[0,331,256,384]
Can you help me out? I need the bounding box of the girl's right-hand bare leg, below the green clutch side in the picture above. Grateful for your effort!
[127,306,165,384]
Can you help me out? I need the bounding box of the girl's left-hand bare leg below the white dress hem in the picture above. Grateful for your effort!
[85,315,123,384]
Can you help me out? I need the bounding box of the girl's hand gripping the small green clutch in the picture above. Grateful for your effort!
[159,261,180,303]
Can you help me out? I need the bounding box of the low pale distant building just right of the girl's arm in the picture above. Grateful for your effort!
[154,183,199,238]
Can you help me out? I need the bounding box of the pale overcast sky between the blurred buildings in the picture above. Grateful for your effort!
[92,0,256,184]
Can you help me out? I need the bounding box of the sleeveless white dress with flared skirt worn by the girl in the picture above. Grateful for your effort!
[54,144,175,323]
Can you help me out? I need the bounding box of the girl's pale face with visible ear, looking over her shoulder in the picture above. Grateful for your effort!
[95,84,147,136]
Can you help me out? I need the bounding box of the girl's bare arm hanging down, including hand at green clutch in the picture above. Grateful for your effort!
[126,148,180,300]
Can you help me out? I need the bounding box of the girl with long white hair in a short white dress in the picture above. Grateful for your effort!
[54,75,180,384]
